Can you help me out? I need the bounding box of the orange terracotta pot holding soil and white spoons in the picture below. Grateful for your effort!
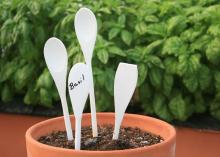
[26,113,176,157]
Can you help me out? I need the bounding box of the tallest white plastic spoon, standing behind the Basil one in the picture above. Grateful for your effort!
[74,8,98,137]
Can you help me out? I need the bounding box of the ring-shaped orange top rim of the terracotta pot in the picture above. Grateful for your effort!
[25,112,176,154]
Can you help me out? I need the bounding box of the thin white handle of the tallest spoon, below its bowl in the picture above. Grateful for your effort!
[88,64,98,137]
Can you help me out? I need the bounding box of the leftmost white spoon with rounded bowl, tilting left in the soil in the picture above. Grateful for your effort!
[44,37,73,140]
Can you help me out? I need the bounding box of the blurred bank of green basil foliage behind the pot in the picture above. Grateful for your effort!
[0,0,220,121]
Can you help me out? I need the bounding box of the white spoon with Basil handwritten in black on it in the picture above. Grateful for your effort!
[68,63,89,150]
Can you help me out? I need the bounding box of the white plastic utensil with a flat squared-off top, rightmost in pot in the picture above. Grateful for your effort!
[113,63,138,140]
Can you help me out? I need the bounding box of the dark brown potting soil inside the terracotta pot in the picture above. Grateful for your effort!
[38,125,164,151]
